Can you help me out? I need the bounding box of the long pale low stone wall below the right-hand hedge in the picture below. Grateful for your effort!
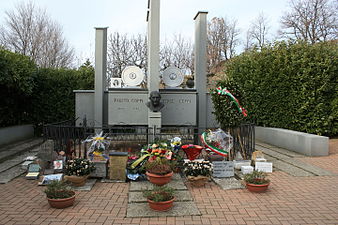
[255,126,329,156]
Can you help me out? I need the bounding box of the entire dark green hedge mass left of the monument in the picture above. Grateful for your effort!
[0,50,94,127]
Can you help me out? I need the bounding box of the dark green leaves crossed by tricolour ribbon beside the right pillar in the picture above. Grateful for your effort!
[211,79,247,130]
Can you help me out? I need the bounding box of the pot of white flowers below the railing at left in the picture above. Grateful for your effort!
[65,158,95,186]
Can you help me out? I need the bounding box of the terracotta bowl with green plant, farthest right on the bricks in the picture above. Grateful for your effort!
[244,170,270,192]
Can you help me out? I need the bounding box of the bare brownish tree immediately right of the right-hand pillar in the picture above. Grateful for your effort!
[207,17,240,70]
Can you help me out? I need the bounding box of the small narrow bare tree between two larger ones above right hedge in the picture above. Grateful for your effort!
[247,12,269,48]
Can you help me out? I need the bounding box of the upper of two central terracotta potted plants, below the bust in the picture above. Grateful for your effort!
[145,157,173,186]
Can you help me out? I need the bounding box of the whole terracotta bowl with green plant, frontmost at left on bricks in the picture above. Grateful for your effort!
[44,180,75,209]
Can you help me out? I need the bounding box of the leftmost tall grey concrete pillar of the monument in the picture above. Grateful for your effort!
[94,27,107,128]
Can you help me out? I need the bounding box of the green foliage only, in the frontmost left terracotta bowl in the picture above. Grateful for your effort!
[44,180,74,199]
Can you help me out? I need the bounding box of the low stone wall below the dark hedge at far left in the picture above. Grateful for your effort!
[0,124,34,145]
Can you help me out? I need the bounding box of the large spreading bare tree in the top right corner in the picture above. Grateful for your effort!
[280,0,338,43]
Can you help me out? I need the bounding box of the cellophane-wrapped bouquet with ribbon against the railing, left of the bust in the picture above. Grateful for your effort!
[83,131,110,160]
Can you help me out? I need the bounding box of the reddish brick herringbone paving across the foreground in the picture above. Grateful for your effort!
[0,139,338,224]
